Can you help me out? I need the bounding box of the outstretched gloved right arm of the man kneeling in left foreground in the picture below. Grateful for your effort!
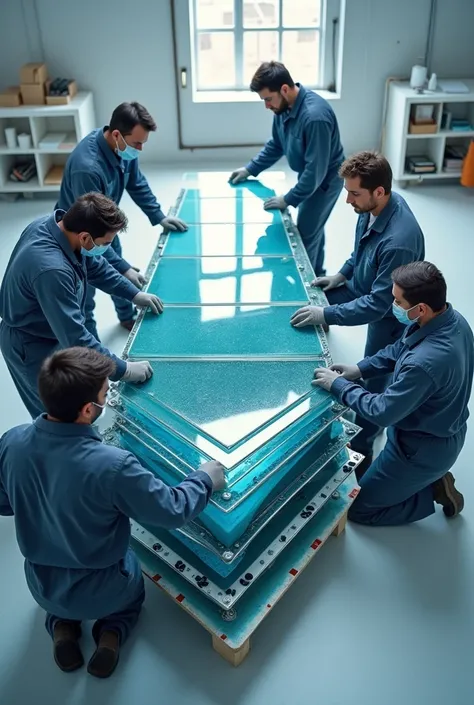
[113,453,225,529]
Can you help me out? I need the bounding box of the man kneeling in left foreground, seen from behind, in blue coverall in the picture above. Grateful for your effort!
[0,348,225,678]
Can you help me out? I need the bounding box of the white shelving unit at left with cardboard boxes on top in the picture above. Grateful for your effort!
[0,92,96,193]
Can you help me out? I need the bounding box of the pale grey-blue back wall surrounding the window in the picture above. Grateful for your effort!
[0,0,474,162]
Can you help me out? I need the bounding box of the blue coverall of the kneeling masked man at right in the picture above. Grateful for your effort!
[331,304,474,525]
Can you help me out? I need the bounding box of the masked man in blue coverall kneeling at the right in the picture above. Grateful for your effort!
[315,262,474,525]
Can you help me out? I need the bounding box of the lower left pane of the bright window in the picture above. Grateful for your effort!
[197,32,235,90]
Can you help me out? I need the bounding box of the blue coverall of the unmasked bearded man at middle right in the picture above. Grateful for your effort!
[324,192,425,455]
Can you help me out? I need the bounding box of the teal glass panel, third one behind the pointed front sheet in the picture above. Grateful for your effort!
[163,222,292,257]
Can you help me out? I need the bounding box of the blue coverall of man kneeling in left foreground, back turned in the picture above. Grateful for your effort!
[0,415,212,643]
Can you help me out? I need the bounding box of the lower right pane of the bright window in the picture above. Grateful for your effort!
[281,29,319,86]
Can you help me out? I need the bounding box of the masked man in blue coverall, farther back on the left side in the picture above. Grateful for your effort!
[56,103,187,340]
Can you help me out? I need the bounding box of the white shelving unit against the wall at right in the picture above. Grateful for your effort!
[383,79,474,183]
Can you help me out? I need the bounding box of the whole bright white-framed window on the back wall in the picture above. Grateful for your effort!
[190,0,325,91]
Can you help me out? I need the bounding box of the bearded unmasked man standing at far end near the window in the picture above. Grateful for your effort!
[230,61,344,276]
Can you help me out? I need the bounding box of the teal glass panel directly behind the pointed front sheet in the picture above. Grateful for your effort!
[128,304,323,359]
